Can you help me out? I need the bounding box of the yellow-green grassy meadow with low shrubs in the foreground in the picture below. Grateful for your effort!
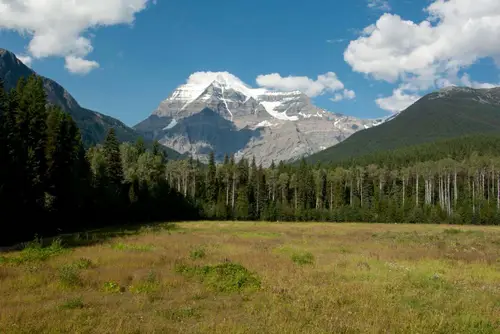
[0,222,500,333]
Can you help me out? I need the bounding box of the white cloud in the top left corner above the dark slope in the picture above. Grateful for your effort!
[0,0,149,73]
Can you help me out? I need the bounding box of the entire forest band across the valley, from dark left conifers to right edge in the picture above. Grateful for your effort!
[0,75,500,244]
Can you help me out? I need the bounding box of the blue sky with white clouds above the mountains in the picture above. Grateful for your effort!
[0,0,500,125]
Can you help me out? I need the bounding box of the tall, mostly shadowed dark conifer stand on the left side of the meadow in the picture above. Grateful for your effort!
[0,75,197,243]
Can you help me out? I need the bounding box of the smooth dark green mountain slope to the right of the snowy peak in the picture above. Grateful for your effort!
[308,87,500,162]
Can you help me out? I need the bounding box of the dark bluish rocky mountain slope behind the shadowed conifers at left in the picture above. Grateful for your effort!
[0,49,179,158]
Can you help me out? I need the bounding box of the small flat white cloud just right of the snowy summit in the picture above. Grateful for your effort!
[257,72,350,97]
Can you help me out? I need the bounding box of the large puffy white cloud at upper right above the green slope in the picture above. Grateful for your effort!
[344,0,500,110]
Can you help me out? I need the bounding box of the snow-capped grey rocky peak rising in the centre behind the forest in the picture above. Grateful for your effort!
[135,72,383,166]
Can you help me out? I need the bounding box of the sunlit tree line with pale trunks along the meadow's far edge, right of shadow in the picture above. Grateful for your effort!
[167,153,500,224]
